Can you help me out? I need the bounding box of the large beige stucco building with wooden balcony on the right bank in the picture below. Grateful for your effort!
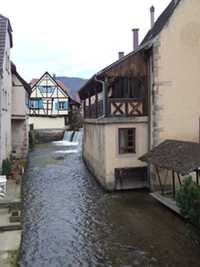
[79,0,200,193]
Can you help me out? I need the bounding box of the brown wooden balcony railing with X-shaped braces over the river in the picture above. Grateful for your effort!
[84,98,147,118]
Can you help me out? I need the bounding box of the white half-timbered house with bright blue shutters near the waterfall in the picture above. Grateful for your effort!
[29,72,71,129]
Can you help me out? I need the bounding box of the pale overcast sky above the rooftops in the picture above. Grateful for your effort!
[0,0,171,82]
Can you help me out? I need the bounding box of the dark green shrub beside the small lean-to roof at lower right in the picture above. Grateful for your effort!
[176,176,200,242]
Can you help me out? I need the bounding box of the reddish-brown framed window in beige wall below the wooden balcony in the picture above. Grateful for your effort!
[119,128,136,154]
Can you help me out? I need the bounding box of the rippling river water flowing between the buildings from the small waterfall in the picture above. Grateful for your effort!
[18,135,200,267]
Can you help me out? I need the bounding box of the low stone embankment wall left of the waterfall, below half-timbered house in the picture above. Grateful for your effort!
[29,129,64,147]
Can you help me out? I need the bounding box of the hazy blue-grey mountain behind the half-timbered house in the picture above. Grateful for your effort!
[56,76,88,99]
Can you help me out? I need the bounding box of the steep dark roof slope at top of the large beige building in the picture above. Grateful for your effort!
[140,0,181,45]
